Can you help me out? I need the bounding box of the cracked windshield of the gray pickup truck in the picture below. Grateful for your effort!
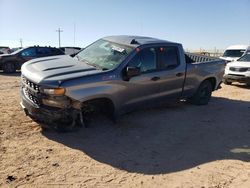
[75,39,133,70]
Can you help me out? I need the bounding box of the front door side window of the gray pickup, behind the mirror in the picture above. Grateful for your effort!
[128,48,157,73]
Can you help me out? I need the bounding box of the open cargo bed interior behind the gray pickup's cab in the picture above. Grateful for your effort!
[185,53,220,64]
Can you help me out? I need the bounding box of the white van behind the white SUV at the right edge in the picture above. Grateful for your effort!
[220,45,250,62]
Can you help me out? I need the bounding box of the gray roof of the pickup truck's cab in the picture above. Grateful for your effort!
[102,35,180,47]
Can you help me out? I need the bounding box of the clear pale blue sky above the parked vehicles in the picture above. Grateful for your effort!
[0,0,250,49]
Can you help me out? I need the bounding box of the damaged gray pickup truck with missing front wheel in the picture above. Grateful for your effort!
[21,36,225,129]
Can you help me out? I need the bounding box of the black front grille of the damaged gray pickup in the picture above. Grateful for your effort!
[21,75,41,106]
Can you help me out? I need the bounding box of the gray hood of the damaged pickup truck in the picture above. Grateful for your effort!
[21,55,102,86]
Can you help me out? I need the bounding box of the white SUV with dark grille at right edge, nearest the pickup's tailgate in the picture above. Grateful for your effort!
[223,52,250,85]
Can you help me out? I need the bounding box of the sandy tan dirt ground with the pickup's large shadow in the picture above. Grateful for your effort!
[0,73,250,188]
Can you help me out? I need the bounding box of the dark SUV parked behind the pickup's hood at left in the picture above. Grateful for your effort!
[0,46,64,73]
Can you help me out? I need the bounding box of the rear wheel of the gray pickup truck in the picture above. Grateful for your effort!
[191,80,213,105]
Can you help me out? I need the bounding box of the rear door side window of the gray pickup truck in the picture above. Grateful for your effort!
[159,46,179,69]
